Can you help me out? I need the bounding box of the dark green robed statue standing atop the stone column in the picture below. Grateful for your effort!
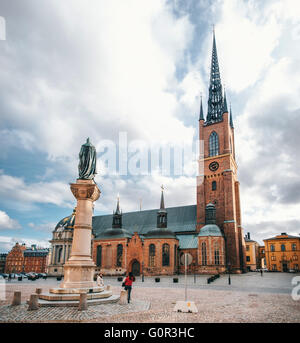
[78,138,97,180]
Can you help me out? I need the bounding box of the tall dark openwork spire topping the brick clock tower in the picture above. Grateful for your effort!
[206,30,223,123]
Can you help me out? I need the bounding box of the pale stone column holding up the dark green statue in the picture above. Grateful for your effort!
[60,179,101,288]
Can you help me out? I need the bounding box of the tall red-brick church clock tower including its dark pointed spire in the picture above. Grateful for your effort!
[197,32,246,273]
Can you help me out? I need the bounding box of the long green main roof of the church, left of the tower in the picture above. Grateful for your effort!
[93,205,197,239]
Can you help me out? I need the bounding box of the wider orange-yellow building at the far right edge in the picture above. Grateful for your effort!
[264,232,300,272]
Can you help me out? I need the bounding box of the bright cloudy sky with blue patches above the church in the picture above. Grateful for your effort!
[0,0,300,252]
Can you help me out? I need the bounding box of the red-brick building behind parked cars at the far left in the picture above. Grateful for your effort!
[5,243,49,273]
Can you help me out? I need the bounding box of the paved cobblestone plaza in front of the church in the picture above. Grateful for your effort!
[0,273,300,323]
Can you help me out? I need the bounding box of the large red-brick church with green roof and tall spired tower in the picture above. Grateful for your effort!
[51,34,246,275]
